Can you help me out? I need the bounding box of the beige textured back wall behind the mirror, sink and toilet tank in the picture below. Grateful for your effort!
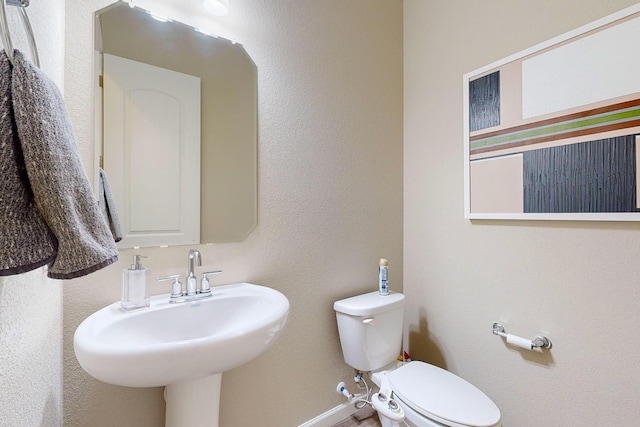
[64,0,402,427]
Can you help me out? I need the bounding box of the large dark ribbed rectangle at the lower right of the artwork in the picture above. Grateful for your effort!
[523,135,638,213]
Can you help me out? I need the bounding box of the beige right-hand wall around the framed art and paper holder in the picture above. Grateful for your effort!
[404,0,640,427]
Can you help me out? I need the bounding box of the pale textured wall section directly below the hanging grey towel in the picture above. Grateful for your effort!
[0,268,62,427]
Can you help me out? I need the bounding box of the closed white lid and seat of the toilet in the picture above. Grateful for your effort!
[387,361,500,427]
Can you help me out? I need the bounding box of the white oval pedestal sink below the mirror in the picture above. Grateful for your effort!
[73,283,289,427]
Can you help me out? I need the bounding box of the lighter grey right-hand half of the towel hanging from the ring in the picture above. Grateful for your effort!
[11,50,118,279]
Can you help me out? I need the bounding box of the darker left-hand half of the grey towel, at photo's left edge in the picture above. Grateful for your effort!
[0,51,57,276]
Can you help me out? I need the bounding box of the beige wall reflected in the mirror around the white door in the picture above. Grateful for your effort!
[94,1,258,249]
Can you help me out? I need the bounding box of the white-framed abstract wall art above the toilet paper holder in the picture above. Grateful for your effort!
[463,4,640,221]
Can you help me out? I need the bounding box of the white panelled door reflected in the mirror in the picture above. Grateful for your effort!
[103,54,200,247]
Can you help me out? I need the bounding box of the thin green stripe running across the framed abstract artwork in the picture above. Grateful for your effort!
[469,107,640,150]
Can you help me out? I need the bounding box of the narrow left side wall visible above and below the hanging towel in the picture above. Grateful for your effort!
[0,0,64,427]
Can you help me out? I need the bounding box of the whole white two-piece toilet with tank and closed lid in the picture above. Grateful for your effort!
[333,291,501,427]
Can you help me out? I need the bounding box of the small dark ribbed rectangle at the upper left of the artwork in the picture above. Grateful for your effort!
[469,71,500,131]
